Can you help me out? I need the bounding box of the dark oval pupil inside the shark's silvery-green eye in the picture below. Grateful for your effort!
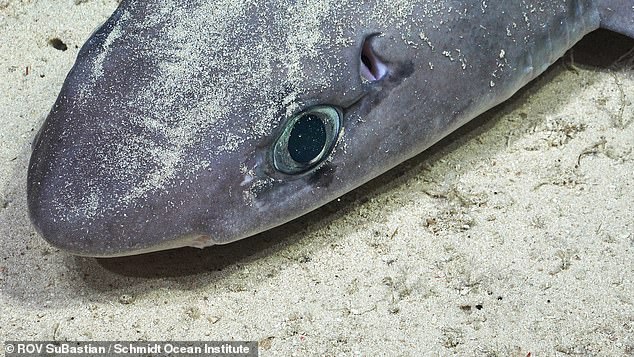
[288,114,326,164]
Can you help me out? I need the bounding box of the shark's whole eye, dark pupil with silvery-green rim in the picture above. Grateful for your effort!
[273,105,342,175]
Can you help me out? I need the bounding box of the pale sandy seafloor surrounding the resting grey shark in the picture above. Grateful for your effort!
[0,0,634,356]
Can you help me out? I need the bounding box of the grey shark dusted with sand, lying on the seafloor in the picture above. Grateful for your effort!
[28,0,634,257]
